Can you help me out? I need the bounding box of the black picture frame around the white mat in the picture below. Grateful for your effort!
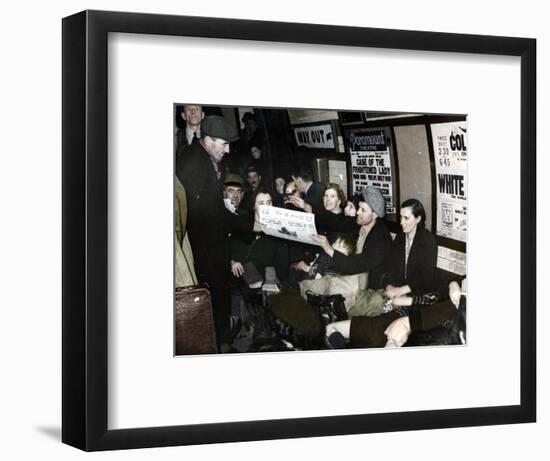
[62,11,536,451]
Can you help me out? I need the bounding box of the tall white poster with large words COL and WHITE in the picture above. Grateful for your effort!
[431,122,468,242]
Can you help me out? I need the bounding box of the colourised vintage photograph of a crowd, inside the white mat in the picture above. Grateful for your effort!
[173,106,468,356]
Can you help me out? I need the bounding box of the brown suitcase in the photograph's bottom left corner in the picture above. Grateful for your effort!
[176,287,217,355]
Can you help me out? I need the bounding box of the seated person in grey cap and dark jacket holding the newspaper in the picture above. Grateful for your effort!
[313,186,392,289]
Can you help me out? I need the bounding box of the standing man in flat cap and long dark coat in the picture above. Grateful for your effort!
[176,115,251,350]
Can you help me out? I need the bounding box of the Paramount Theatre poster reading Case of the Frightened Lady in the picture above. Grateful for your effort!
[349,130,395,210]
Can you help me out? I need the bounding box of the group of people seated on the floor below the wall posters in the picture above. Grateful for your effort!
[218,169,465,348]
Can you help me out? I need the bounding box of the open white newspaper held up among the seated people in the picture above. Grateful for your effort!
[260,205,318,245]
